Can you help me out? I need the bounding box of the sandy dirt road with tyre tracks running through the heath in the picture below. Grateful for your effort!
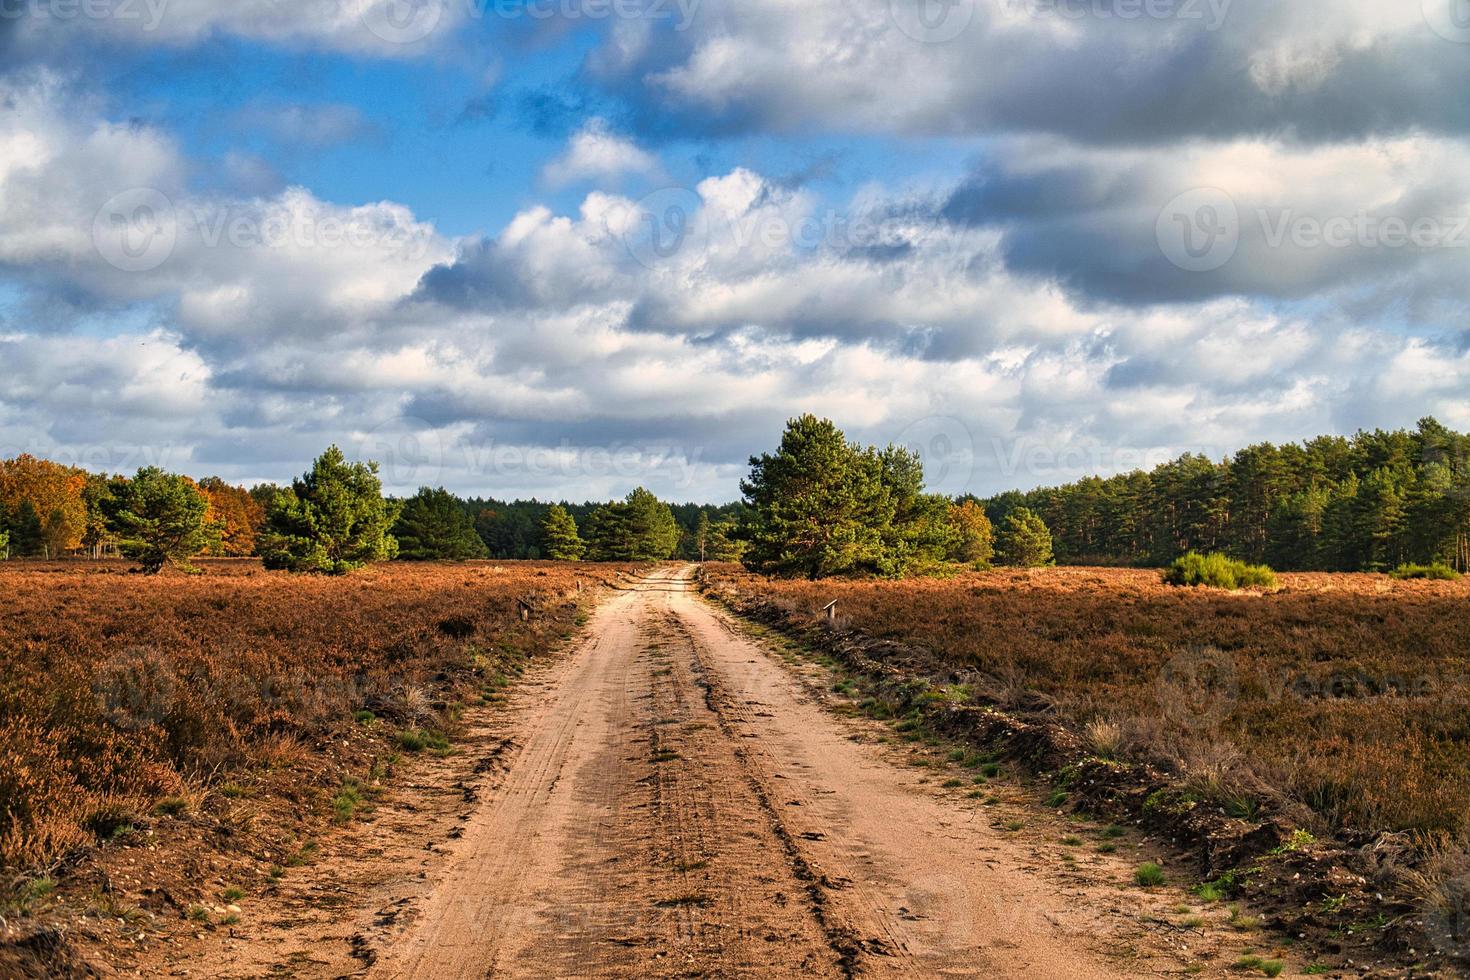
[373,569,1135,979]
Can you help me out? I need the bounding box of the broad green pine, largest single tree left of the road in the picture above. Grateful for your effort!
[259,445,398,574]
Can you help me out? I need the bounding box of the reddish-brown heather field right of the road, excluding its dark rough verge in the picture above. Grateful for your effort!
[706,566,1470,843]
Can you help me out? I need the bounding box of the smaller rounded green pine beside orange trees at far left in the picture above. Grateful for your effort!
[104,466,219,574]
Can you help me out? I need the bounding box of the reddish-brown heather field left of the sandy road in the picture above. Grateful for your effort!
[0,561,632,870]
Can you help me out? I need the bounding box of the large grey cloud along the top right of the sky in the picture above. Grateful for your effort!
[589,0,1470,144]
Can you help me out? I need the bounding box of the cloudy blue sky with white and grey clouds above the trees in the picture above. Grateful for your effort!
[0,0,1470,502]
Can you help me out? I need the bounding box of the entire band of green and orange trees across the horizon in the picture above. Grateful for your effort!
[0,416,1470,576]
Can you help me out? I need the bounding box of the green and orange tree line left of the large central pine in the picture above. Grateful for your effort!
[0,447,742,573]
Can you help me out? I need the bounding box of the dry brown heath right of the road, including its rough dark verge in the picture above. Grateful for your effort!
[704,566,1470,977]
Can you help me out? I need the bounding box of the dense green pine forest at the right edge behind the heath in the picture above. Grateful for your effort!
[980,419,1470,572]
